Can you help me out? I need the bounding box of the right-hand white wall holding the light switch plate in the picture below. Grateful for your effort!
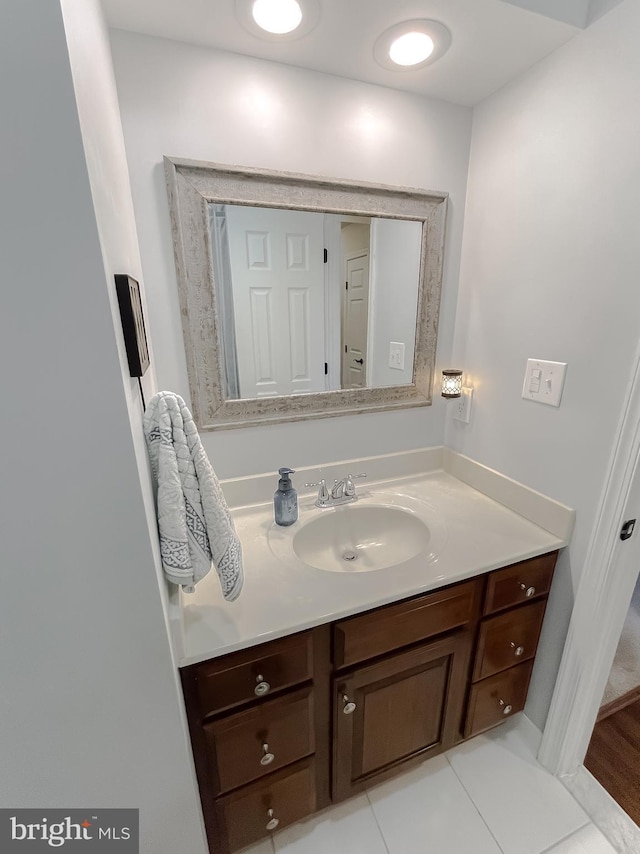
[446,0,640,724]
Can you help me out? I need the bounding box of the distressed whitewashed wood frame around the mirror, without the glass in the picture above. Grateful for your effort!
[164,157,447,430]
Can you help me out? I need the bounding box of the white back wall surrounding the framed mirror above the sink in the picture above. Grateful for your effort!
[112,31,471,477]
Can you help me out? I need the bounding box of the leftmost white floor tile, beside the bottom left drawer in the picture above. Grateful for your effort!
[273,795,387,854]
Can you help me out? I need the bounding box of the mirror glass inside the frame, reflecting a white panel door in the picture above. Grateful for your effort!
[208,202,423,400]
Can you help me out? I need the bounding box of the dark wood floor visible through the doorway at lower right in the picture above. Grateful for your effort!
[584,700,640,825]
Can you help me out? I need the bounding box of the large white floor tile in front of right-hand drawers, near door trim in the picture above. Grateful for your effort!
[447,716,589,854]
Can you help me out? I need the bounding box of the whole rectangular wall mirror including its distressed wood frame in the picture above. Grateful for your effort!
[165,157,447,430]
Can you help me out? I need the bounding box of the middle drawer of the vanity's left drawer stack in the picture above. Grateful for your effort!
[204,687,314,794]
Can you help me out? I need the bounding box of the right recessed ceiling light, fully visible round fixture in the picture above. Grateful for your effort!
[373,19,451,71]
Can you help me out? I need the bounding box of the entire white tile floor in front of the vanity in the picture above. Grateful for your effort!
[243,715,615,854]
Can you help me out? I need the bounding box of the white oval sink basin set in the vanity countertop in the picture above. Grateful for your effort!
[269,494,445,573]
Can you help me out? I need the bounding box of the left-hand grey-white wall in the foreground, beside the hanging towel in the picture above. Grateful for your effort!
[0,0,205,854]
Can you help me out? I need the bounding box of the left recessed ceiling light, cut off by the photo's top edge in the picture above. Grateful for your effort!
[235,0,320,41]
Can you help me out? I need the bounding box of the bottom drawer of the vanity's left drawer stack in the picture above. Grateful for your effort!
[216,759,316,851]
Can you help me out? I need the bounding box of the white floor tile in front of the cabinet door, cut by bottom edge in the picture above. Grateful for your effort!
[364,756,501,854]
